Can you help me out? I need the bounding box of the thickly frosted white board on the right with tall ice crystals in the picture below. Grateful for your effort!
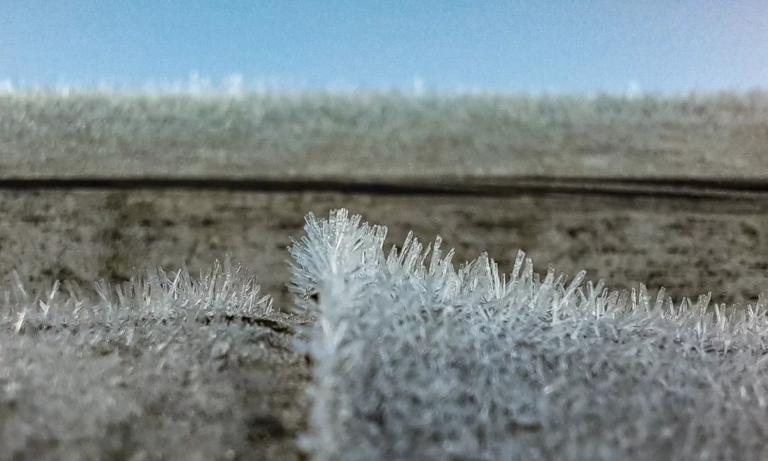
[291,209,768,460]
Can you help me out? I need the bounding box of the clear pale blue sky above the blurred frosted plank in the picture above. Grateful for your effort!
[0,0,768,92]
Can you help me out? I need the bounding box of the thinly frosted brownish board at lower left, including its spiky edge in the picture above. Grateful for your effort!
[0,260,298,460]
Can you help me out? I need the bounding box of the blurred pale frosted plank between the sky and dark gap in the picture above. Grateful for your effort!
[0,93,768,182]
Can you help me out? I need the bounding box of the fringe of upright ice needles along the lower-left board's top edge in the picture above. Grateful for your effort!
[0,254,274,343]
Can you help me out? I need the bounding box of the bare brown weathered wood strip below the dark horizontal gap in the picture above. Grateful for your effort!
[0,190,768,307]
